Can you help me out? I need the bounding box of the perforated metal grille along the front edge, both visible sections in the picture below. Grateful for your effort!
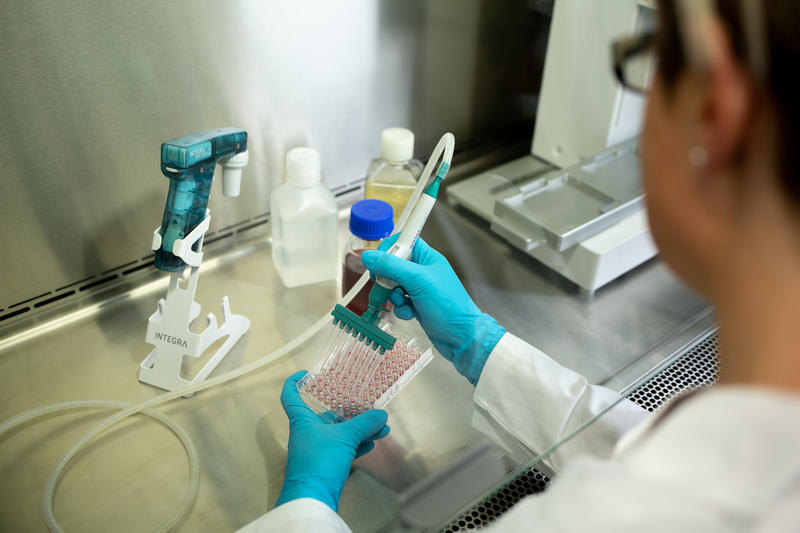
[442,333,719,533]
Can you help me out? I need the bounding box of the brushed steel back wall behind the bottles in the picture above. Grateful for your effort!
[0,0,552,311]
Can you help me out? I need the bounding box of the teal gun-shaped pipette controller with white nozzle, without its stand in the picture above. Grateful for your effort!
[155,128,248,272]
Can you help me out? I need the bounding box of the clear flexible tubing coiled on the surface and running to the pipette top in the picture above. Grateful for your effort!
[0,133,455,533]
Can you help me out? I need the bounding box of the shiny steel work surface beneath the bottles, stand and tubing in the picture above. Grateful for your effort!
[0,197,706,531]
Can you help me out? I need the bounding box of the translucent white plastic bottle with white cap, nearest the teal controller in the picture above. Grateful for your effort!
[270,148,338,287]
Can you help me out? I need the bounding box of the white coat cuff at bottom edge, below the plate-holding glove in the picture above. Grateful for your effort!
[237,498,351,533]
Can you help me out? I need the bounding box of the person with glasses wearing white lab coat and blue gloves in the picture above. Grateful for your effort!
[244,0,800,532]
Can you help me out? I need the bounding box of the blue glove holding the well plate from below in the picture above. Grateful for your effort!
[275,370,389,511]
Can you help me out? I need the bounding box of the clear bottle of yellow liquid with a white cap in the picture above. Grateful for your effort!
[364,128,422,223]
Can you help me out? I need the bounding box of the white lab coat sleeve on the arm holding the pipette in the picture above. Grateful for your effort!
[472,333,648,471]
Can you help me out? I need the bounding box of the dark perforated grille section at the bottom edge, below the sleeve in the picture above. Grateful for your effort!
[442,468,550,533]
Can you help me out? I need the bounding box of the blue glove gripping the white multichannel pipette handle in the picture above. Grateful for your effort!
[361,235,506,385]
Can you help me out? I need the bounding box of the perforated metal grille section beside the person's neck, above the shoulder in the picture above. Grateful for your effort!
[628,333,719,412]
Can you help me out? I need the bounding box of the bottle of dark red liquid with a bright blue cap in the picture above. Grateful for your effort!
[342,199,394,315]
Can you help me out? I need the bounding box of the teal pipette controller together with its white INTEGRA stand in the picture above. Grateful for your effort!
[139,128,250,390]
